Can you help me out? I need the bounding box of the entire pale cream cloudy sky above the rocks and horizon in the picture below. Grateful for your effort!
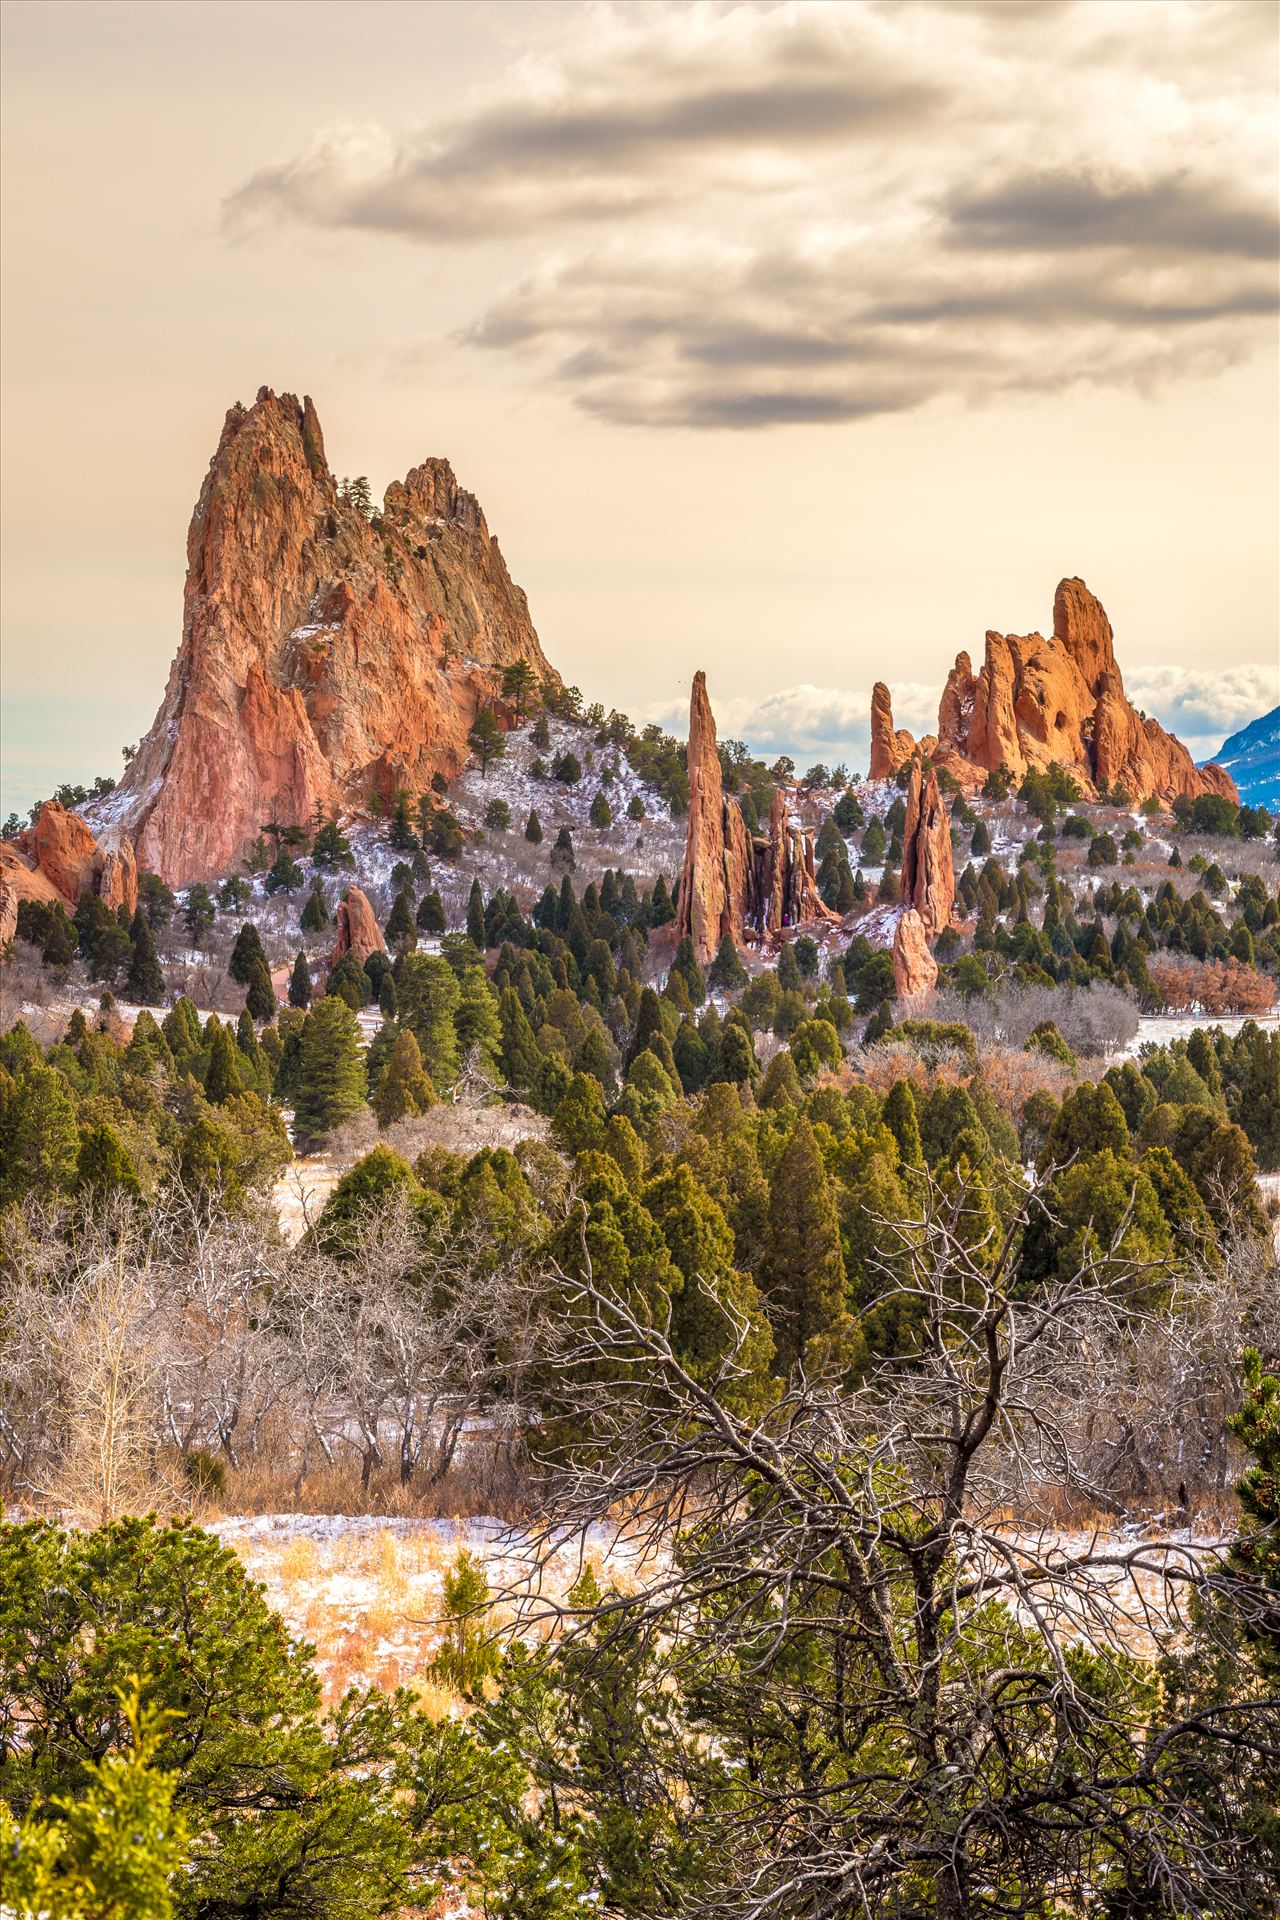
[2,0,1280,810]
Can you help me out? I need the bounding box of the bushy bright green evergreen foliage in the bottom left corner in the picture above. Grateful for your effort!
[0,1519,422,1920]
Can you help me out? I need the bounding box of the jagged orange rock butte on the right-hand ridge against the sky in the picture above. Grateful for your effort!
[871,580,1238,804]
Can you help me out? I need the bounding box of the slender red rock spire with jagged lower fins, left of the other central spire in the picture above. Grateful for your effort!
[676,672,839,966]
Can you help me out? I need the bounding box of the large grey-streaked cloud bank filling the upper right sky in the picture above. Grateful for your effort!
[228,0,1276,428]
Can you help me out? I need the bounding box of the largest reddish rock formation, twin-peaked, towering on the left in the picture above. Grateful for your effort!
[97,388,557,885]
